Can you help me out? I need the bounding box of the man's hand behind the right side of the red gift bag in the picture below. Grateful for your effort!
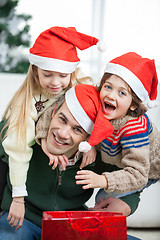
[88,197,131,216]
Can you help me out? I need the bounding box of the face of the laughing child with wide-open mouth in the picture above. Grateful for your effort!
[100,75,135,120]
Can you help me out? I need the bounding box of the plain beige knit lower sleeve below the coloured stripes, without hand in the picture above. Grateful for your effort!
[103,145,150,193]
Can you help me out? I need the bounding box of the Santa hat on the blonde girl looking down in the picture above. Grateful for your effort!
[29,27,104,73]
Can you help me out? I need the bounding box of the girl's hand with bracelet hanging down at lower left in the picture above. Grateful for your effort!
[7,197,25,230]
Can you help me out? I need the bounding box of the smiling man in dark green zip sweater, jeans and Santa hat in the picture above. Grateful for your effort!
[0,85,139,240]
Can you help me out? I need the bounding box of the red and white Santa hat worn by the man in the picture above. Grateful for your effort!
[65,84,114,152]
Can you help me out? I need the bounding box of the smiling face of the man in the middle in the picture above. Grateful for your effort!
[47,102,88,155]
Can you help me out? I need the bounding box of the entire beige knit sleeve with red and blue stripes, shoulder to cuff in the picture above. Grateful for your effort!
[103,115,152,193]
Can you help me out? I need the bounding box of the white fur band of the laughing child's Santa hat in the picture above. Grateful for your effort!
[104,63,149,102]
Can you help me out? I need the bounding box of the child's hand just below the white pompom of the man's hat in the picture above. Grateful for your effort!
[80,146,97,169]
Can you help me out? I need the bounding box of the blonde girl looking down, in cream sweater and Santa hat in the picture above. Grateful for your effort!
[0,27,102,229]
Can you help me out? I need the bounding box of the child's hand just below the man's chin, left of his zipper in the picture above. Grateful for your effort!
[49,154,69,170]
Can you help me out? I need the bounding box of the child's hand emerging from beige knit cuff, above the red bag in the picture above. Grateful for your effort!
[75,170,107,189]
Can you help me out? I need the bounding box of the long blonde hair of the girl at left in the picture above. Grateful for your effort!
[1,64,93,146]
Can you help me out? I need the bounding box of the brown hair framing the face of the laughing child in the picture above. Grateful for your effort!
[98,73,147,117]
